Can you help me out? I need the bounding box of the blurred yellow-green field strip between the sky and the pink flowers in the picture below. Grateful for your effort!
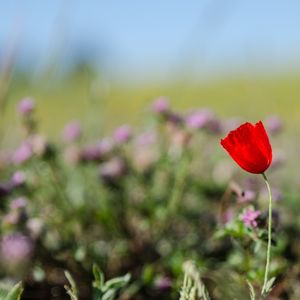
[4,74,300,141]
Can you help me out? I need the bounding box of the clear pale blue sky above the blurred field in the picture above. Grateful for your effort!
[0,0,300,78]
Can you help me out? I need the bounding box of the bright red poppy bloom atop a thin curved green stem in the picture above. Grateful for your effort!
[221,121,272,174]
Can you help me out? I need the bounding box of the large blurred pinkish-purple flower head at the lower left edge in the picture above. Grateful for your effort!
[0,233,33,265]
